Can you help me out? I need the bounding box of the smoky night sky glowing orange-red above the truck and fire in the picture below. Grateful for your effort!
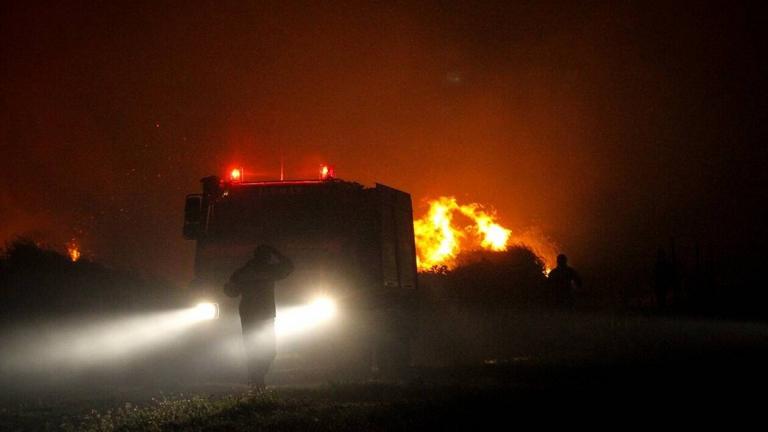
[0,1,768,283]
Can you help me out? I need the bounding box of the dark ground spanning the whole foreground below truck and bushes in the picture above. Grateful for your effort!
[0,290,768,431]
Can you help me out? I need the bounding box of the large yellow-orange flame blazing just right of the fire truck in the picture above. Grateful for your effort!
[413,196,557,273]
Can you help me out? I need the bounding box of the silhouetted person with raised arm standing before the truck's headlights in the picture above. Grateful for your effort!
[224,245,293,388]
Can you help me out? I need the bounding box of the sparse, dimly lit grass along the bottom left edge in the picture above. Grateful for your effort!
[0,384,520,432]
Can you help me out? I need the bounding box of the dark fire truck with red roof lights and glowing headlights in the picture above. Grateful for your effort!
[183,166,417,371]
